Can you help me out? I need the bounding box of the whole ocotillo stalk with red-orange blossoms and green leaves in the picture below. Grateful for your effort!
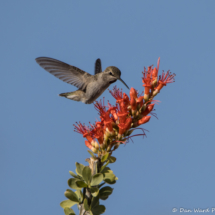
[60,58,175,215]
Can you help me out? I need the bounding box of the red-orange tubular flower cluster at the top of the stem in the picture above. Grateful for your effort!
[74,58,175,157]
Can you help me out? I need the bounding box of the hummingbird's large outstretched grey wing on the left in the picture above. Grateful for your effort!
[36,57,91,90]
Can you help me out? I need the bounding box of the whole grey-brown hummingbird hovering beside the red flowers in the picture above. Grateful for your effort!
[35,57,129,104]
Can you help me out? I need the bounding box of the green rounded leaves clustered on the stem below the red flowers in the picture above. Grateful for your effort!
[60,159,118,215]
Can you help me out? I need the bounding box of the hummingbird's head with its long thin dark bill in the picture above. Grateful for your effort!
[104,66,129,89]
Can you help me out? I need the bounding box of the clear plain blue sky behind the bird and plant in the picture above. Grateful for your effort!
[0,0,215,215]
